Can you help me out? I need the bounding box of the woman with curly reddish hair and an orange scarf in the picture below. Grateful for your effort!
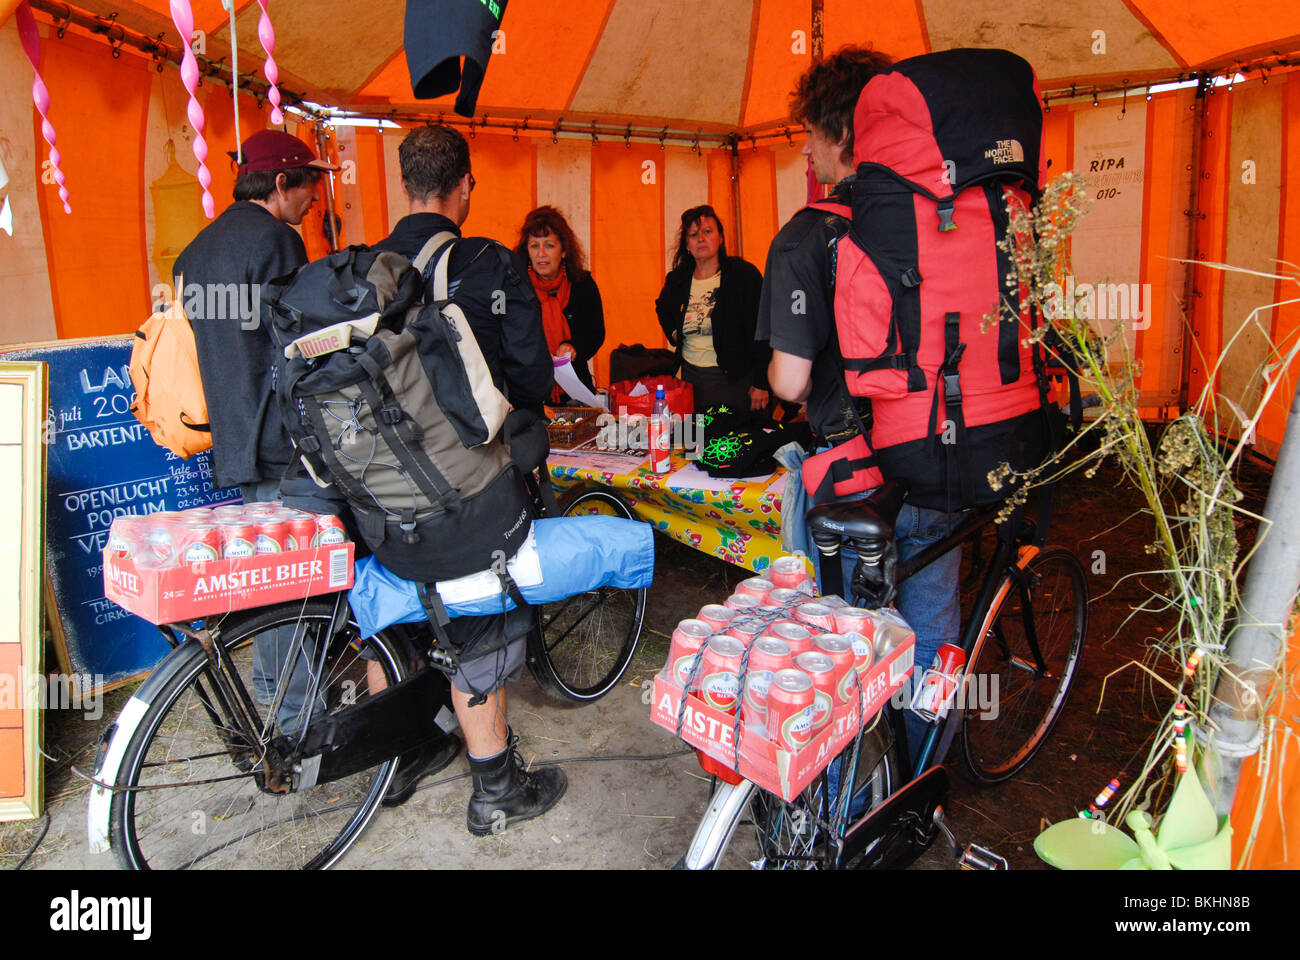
[515,206,605,401]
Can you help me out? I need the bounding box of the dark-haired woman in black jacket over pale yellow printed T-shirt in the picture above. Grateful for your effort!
[655,204,771,411]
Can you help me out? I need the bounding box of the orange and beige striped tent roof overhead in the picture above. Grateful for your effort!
[55,0,1300,131]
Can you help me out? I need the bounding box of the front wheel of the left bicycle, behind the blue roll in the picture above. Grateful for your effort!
[528,488,646,704]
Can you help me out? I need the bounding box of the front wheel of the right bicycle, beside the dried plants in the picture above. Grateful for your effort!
[961,548,1088,783]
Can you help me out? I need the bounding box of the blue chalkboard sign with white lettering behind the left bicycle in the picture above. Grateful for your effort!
[0,337,239,688]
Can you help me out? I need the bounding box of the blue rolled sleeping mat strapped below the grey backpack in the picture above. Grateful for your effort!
[348,516,654,636]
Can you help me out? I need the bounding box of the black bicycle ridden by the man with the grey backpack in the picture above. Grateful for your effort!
[90,484,646,869]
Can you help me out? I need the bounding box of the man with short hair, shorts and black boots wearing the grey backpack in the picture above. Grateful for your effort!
[374,125,568,835]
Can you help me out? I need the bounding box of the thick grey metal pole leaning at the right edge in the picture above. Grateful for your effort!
[1206,369,1300,816]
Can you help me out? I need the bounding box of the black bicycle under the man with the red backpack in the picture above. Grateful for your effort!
[677,484,1088,869]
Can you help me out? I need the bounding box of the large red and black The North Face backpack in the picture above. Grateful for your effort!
[835,49,1049,510]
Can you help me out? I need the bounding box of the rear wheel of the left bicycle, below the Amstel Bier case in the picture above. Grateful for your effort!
[109,598,407,869]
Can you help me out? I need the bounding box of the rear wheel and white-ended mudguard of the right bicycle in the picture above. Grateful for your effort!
[676,728,902,870]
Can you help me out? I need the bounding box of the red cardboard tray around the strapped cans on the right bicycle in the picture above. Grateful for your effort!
[650,636,915,800]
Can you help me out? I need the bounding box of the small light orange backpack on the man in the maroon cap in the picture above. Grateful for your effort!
[131,282,212,459]
